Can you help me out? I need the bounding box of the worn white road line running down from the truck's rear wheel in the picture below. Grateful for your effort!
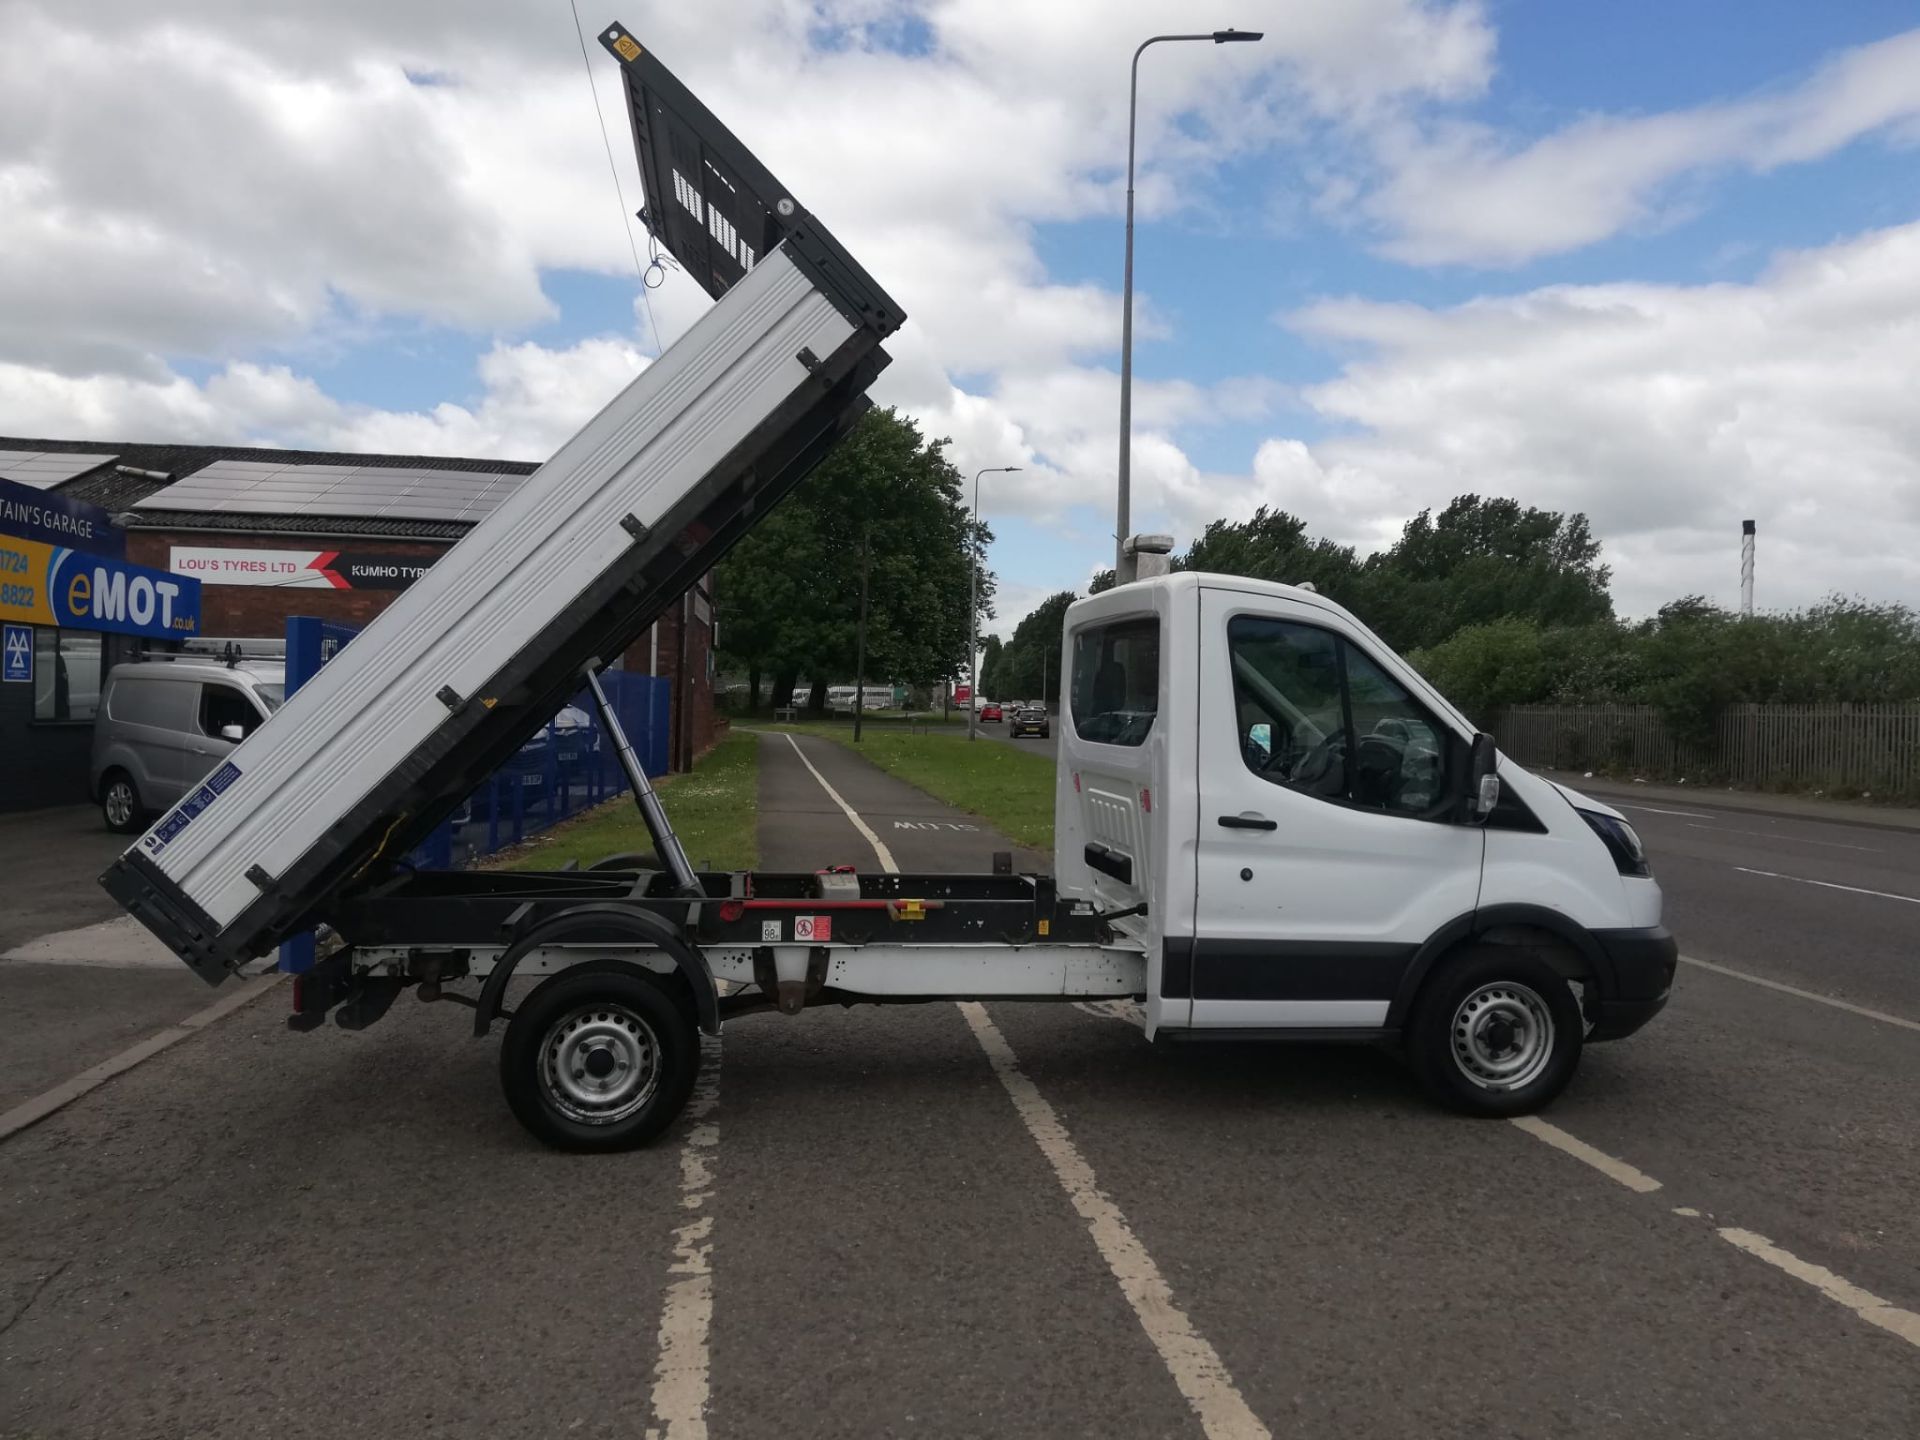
[647,1035,720,1440]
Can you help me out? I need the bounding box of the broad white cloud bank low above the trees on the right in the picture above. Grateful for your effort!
[1221,223,1920,612]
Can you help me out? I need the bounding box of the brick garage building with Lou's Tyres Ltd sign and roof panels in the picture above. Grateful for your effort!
[0,436,714,810]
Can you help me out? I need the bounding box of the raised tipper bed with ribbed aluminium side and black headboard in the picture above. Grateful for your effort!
[102,25,904,983]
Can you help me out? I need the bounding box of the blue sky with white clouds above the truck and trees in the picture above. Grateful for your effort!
[0,0,1920,636]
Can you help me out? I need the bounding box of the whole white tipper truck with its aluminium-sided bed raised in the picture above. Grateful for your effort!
[102,25,1676,1150]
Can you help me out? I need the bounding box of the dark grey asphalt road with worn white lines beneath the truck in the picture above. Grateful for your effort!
[0,735,1920,1440]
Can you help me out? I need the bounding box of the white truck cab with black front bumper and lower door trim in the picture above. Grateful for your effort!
[1054,574,1676,1108]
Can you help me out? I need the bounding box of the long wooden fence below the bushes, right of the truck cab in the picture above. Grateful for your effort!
[1492,703,1920,801]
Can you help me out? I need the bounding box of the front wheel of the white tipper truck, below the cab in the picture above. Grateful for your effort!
[1407,945,1584,1116]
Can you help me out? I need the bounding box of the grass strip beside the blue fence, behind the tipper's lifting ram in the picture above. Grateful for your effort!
[499,730,760,870]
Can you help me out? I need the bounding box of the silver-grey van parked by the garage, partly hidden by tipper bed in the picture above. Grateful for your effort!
[88,655,286,835]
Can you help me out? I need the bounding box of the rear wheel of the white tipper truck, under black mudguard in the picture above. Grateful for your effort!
[499,960,701,1150]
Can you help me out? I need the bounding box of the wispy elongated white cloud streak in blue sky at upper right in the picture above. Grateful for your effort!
[1357,31,1920,265]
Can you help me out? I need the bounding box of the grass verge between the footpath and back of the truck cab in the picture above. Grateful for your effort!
[768,726,1054,851]
